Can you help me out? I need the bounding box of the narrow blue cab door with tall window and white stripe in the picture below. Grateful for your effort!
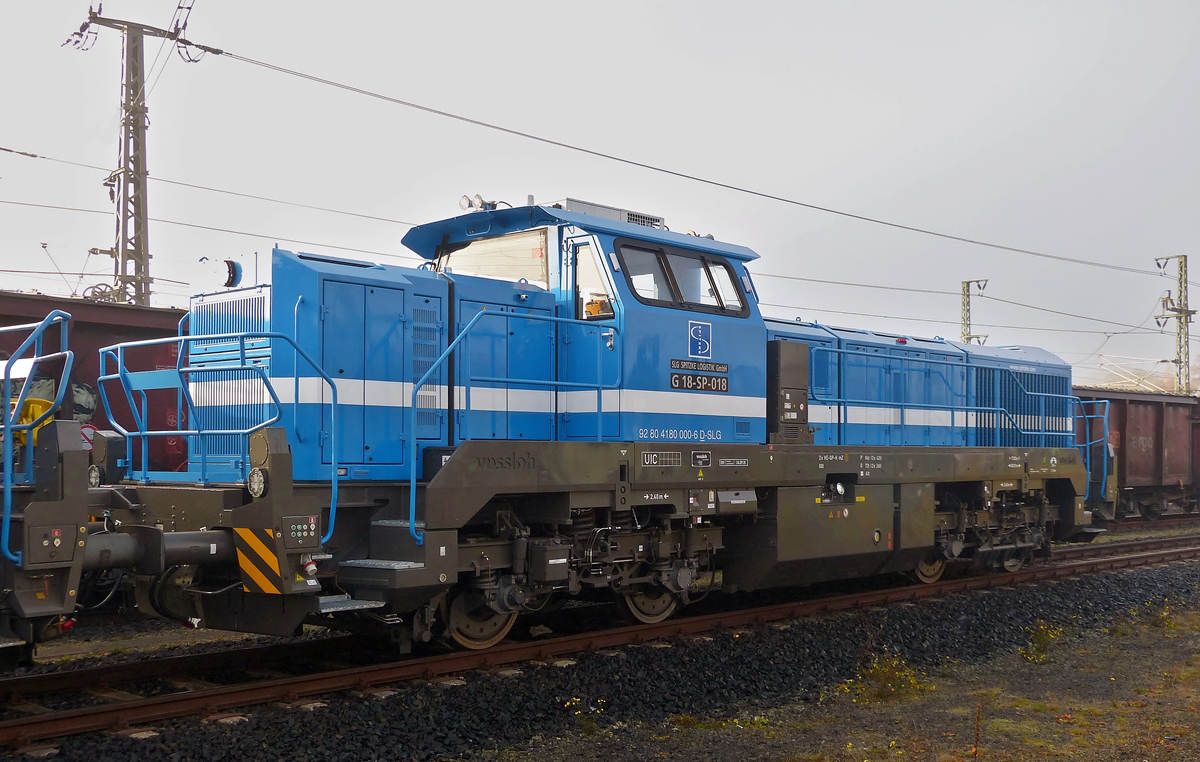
[558,239,620,439]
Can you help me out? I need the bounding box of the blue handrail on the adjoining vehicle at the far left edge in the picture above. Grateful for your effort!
[0,310,74,566]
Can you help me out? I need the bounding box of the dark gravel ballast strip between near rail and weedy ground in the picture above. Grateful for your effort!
[9,563,1200,762]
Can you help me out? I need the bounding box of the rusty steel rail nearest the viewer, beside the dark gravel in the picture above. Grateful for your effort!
[0,545,1200,746]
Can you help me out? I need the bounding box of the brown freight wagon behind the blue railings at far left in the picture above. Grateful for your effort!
[0,292,187,469]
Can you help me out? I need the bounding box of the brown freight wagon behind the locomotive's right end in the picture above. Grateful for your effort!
[1074,386,1200,520]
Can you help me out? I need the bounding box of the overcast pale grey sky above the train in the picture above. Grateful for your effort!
[0,0,1200,382]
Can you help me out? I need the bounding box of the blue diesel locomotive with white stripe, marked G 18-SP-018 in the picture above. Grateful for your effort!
[4,202,1093,648]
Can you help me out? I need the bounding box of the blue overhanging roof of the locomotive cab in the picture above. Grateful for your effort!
[402,206,758,262]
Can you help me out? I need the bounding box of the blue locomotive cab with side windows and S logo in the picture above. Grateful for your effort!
[404,199,767,442]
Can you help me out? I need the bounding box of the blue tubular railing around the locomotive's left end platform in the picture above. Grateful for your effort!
[96,331,338,545]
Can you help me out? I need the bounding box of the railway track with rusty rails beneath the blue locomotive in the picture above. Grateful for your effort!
[0,535,1200,748]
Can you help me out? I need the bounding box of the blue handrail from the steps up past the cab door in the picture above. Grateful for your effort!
[408,308,622,545]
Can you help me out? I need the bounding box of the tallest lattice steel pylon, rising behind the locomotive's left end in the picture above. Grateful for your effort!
[64,6,193,306]
